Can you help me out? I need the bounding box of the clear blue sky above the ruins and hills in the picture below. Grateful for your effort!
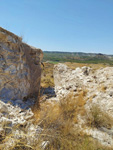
[0,0,113,54]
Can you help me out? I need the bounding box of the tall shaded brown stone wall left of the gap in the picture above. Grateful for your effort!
[0,28,43,100]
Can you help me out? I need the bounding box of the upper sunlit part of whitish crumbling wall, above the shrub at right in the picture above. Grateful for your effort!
[54,64,113,116]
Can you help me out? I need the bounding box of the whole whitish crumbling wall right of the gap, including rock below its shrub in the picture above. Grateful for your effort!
[54,64,113,147]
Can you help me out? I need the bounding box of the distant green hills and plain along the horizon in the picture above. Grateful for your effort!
[43,51,113,65]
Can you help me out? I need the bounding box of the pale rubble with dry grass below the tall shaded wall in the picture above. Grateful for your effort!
[0,101,42,150]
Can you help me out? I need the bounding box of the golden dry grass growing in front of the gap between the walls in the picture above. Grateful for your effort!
[30,91,110,150]
